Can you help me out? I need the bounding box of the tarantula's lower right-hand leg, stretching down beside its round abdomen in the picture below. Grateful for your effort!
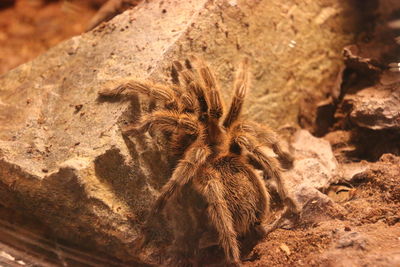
[234,133,299,214]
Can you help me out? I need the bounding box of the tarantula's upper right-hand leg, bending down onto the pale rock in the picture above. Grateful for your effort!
[233,122,294,169]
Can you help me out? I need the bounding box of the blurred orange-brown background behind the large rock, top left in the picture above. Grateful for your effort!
[0,0,139,75]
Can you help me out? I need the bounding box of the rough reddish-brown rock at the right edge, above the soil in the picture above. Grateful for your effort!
[344,83,400,130]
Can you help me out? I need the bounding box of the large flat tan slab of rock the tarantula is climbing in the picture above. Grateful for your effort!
[0,0,353,260]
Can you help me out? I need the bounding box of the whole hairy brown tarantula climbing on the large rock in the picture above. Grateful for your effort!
[100,56,296,265]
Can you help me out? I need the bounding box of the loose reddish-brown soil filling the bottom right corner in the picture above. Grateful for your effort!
[245,154,400,266]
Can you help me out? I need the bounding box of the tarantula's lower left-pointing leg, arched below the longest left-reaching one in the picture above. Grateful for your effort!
[124,110,201,135]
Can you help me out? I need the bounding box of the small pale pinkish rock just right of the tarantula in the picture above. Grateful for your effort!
[284,130,344,224]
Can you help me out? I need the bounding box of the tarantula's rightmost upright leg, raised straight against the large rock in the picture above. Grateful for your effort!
[223,59,249,128]
